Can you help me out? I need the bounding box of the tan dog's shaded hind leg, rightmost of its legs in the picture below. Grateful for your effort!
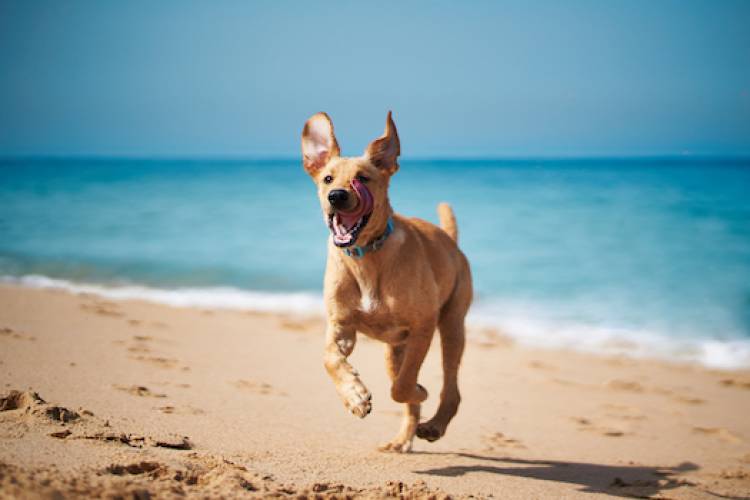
[417,284,471,441]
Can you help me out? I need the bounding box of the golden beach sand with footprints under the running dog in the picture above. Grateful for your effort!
[0,286,750,499]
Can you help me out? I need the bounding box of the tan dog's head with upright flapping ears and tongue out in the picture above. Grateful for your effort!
[302,111,401,247]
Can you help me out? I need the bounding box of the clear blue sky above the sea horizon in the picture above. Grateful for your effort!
[0,0,750,157]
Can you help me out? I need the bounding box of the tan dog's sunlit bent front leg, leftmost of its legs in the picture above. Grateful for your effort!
[325,324,372,418]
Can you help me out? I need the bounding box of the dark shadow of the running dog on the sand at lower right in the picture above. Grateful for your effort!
[414,452,722,498]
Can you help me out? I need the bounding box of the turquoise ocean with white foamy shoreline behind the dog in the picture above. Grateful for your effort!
[0,158,750,368]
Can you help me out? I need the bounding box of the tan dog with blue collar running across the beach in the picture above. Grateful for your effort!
[302,112,472,452]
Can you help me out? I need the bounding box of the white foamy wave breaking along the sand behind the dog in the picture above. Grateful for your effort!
[0,275,750,369]
